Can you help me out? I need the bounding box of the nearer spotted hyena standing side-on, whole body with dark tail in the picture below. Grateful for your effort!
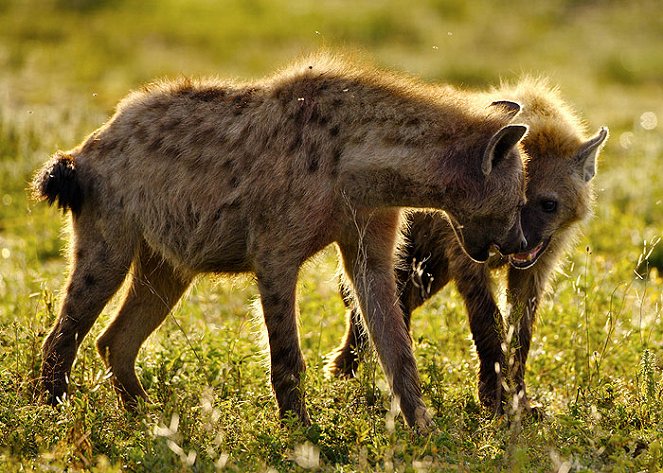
[34,55,526,426]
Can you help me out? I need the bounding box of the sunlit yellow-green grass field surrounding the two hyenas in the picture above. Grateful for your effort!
[0,0,663,472]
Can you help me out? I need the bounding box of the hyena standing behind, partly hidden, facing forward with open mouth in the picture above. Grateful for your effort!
[328,79,608,411]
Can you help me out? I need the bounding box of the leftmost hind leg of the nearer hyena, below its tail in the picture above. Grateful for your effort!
[41,214,134,405]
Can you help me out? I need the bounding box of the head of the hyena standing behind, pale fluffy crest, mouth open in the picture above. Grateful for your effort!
[482,78,608,269]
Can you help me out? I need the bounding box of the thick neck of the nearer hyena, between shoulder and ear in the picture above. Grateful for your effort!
[308,79,505,209]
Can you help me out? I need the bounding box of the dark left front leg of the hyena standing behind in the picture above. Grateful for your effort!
[450,255,506,413]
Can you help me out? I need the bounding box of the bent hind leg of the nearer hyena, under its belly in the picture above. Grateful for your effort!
[97,243,191,409]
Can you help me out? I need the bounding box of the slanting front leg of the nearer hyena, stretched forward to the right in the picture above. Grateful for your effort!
[338,210,431,430]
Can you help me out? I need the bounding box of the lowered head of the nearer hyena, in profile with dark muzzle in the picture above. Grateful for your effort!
[447,110,527,262]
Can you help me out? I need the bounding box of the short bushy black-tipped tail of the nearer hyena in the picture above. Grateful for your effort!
[32,152,83,215]
